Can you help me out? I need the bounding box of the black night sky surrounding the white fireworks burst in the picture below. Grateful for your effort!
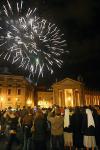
[1,0,100,89]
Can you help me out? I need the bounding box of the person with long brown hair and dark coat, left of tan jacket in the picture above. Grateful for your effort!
[32,109,47,150]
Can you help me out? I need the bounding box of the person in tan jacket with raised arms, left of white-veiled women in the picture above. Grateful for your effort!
[47,108,64,150]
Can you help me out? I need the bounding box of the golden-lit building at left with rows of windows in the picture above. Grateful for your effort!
[0,74,34,109]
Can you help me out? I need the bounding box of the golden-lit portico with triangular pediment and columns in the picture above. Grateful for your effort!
[52,78,85,107]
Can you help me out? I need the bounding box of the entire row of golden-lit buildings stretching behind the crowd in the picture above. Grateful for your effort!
[0,74,100,109]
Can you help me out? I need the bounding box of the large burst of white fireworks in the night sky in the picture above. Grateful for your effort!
[0,0,66,77]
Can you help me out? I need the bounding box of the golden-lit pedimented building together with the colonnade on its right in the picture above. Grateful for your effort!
[52,78,100,107]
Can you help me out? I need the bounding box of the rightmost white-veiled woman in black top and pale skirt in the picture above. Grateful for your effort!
[82,108,96,150]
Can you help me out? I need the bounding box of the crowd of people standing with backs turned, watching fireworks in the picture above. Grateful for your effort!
[0,105,100,150]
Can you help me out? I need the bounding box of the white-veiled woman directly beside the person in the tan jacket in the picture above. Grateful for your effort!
[64,108,73,149]
